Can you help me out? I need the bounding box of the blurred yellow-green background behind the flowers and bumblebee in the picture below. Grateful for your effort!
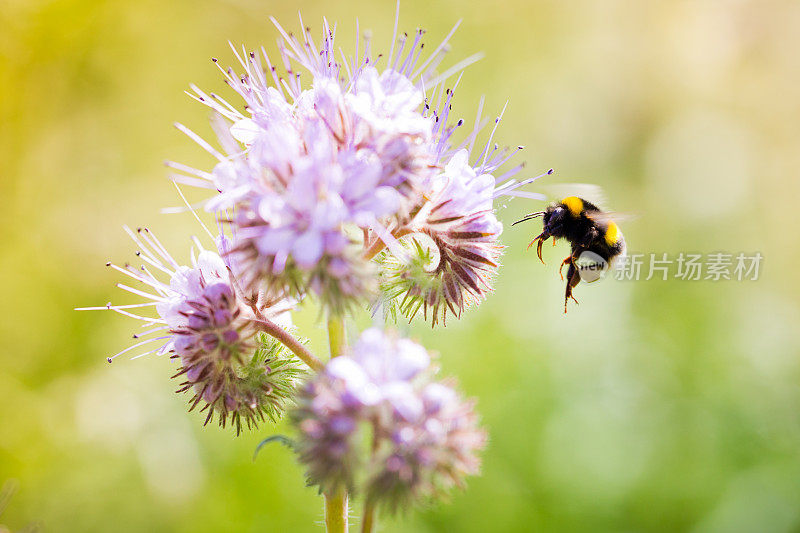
[0,0,800,532]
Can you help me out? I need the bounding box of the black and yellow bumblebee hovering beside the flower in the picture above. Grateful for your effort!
[512,196,625,313]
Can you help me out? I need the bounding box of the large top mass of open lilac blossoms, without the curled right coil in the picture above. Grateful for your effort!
[166,16,494,312]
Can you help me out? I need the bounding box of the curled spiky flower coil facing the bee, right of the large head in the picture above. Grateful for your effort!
[380,89,552,326]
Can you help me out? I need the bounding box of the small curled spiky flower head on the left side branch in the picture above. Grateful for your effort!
[79,228,300,434]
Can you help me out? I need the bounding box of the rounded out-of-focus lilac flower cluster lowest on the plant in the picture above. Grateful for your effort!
[293,329,485,510]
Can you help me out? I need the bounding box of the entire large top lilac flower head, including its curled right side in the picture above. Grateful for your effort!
[171,16,548,324]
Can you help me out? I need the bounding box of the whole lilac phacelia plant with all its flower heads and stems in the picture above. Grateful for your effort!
[79,11,552,531]
